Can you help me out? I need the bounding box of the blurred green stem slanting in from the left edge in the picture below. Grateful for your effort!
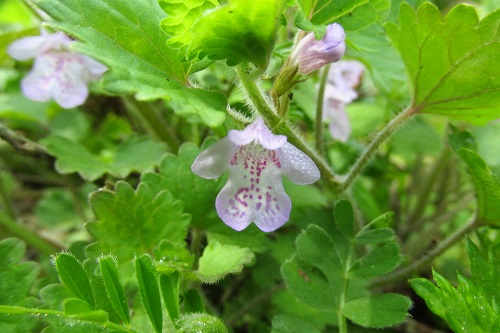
[0,211,62,255]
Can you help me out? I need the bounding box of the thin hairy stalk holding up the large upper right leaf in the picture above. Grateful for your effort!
[342,107,419,190]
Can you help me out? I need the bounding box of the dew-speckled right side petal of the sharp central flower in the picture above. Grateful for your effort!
[278,143,321,185]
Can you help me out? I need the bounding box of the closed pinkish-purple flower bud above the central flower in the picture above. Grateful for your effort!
[290,23,345,75]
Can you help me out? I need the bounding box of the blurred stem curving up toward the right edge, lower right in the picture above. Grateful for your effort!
[371,215,482,287]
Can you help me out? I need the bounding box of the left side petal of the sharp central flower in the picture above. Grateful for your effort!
[191,137,236,179]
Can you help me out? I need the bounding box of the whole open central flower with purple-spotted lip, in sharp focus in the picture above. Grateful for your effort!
[191,118,320,232]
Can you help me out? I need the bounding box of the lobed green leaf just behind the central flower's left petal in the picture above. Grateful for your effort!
[141,143,220,226]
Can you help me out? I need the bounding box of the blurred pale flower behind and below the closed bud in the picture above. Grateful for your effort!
[323,60,365,142]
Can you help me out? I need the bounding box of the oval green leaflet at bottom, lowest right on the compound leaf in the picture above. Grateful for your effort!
[342,294,412,328]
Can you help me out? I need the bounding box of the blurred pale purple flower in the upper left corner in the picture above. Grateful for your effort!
[7,30,107,108]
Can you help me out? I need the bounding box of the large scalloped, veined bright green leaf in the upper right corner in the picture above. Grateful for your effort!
[386,3,500,123]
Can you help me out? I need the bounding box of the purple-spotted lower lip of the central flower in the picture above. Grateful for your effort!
[215,143,291,232]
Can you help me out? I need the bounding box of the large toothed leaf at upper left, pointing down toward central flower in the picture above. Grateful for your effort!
[38,0,227,127]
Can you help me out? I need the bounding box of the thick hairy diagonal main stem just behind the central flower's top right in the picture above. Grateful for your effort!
[236,65,340,188]
